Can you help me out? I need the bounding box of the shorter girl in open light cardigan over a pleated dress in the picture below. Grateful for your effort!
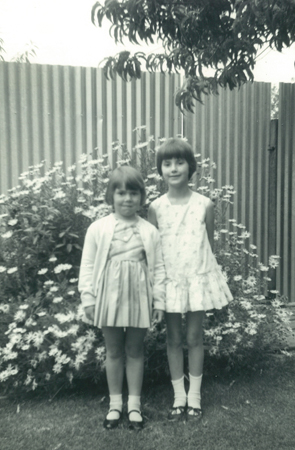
[79,166,166,429]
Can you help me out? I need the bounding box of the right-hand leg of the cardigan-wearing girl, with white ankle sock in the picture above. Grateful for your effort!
[125,327,147,422]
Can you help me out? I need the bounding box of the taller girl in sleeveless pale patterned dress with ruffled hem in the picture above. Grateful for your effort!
[149,138,232,420]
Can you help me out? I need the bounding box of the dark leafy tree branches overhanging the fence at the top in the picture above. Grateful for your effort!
[92,0,295,110]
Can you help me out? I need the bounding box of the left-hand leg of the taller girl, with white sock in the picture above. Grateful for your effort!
[165,313,186,412]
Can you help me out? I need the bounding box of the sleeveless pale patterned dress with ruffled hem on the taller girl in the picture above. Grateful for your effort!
[152,192,232,313]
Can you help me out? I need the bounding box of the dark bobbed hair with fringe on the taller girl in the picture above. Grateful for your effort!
[157,138,197,179]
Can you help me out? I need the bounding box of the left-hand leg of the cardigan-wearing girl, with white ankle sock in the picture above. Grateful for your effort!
[102,327,125,420]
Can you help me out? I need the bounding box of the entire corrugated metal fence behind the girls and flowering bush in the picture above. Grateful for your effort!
[0,62,295,300]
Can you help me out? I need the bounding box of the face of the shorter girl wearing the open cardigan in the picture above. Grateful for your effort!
[113,186,141,220]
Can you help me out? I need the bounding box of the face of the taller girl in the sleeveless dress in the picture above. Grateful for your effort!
[161,158,189,187]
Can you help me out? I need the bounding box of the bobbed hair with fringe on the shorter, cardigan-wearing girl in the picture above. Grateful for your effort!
[105,166,146,206]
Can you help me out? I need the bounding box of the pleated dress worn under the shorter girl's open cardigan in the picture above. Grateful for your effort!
[93,219,153,328]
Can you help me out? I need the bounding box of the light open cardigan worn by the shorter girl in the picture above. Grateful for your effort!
[78,214,166,311]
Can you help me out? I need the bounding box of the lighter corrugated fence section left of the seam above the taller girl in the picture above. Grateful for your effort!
[0,62,182,188]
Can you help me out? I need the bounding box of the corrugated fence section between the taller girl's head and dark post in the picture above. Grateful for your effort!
[184,83,270,268]
